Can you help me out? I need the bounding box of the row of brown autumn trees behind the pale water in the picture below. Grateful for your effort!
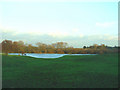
[0,40,119,54]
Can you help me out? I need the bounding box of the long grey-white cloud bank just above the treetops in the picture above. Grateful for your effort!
[0,27,118,47]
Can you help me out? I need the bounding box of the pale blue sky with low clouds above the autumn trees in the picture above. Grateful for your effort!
[0,0,118,48]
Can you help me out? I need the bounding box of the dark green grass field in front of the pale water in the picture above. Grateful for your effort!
[2,54,118,88]
